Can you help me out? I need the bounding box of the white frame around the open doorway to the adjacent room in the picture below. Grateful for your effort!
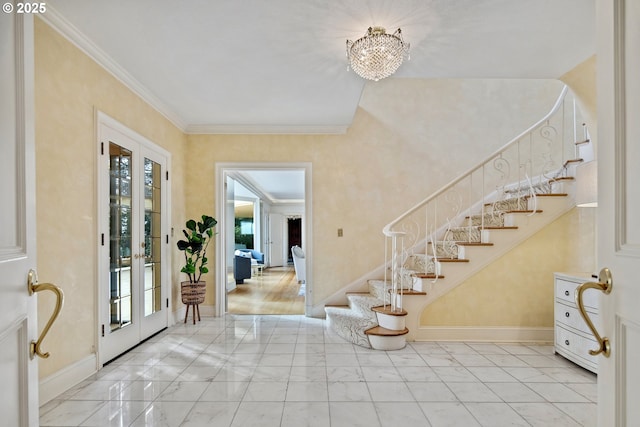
[214,162,313,316]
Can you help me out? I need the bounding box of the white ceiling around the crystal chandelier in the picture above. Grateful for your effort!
[42,0,595,134]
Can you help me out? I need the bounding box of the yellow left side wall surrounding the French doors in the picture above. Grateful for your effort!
[35,19,186,377]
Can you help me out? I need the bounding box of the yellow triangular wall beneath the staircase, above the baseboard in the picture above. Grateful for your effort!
[420,208,596,327]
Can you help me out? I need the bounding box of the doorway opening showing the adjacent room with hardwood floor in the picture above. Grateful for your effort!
[216,163,312,315]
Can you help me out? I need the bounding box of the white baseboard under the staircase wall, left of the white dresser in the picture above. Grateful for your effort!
[414,326,553,343]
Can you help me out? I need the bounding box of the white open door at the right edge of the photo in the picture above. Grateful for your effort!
[590,0,640,427]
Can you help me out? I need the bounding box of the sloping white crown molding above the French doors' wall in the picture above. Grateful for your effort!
[38,4,187,133]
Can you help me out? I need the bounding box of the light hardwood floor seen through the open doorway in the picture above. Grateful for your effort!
[227,267,304,314]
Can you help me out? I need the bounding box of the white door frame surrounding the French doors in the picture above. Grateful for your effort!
[94,109,174,369]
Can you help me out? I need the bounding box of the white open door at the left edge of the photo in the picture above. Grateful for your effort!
[0,10,39,426]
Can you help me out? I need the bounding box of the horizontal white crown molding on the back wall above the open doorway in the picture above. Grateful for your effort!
[185,125,349,135]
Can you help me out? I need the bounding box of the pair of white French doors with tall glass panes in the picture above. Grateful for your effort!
[99,115,170,363]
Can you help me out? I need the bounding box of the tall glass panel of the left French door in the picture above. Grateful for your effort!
[109,143,133,331]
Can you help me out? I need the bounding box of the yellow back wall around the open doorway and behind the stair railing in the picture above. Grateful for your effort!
[187,79,562,304]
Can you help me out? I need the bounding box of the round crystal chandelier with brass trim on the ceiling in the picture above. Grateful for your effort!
[347,27,409,81]
